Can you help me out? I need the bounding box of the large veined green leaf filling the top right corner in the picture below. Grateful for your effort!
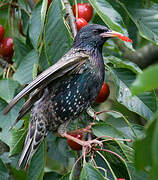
[118,0,158,45]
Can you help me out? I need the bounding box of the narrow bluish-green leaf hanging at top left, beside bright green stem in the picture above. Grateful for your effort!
[29,1,42,49]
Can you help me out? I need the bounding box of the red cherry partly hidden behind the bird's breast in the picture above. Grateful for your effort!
[95,82,110,103]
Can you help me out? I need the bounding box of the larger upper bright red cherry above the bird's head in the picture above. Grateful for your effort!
[73,3,93,22]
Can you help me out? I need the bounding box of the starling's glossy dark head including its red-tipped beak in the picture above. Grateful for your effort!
[74,24,132,48]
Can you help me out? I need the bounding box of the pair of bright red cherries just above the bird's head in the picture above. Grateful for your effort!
[73,3,93,31]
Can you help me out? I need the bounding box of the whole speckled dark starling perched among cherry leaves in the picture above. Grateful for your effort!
[4,24,132,168]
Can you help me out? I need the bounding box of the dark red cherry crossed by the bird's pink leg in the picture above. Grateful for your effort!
[67,134,83,151]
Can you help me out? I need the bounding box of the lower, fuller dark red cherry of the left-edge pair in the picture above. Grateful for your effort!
[0,37,14,57]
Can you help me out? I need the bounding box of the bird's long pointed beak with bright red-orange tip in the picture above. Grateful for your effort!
[101,30,133,43]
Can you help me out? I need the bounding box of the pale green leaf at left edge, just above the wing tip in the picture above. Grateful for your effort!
[0,79,19,103]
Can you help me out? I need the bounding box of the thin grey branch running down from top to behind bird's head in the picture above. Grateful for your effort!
[63,0,77,37]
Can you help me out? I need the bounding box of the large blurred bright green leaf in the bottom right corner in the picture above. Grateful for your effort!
[134,112,158,180]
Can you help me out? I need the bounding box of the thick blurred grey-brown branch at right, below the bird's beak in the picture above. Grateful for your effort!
[114,39,158,69]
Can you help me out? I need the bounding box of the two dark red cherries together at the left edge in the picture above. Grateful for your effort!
[0,24,14,58]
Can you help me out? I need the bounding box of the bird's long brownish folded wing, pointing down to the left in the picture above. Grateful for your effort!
[3,49,89,114]
